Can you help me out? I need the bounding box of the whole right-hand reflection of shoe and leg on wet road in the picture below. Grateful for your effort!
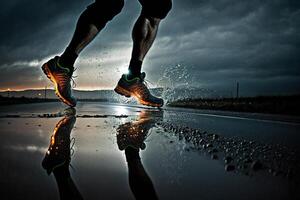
[117,111,163,199]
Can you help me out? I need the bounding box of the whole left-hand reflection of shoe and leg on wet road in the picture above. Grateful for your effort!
[42,109,83,199]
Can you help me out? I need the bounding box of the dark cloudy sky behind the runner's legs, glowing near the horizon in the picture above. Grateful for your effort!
[0,0,300,95]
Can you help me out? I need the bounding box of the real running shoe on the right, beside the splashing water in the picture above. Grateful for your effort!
[115,72,164,107]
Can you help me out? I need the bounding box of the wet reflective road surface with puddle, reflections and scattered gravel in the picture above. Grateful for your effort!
[0,103,300,199]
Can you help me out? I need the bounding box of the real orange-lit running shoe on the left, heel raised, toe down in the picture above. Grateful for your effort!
[42,56,76,107]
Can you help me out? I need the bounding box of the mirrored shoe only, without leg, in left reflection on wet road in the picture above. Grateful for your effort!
[42,115,76,174]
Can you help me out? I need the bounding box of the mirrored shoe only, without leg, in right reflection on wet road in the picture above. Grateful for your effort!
[117,111,163,150]
